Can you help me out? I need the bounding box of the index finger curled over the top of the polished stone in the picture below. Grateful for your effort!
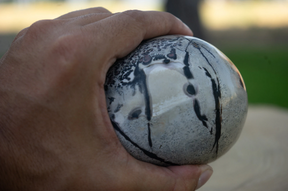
[86,11,193,74]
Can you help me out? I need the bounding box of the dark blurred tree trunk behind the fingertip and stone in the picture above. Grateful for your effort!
[165,0,207,40]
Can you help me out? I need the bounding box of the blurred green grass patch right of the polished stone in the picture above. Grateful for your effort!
[221,46,288,108]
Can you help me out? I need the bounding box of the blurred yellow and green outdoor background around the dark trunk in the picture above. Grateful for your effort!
[0,0,288,108]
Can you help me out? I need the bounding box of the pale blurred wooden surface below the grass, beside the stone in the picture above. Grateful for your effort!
[199,106,288,191]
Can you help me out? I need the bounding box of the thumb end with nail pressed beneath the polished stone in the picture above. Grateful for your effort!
[134,160,213,191]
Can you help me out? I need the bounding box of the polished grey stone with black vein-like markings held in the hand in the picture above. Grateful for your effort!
[105,35,247,166]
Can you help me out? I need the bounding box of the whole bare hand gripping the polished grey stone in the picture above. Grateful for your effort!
[0,8,212,191]
